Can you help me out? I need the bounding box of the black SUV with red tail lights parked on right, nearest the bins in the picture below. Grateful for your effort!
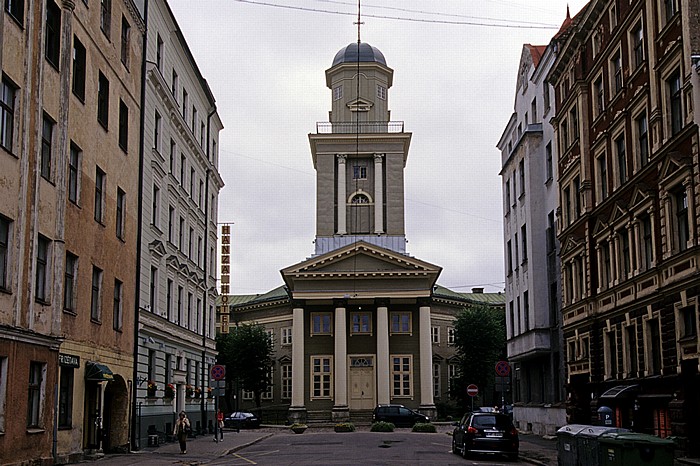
[452,412,519,460]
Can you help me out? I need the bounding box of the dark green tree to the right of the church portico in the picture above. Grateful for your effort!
[451,305,506,408]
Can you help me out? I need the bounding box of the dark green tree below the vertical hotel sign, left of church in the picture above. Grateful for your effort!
[216,323,273,412]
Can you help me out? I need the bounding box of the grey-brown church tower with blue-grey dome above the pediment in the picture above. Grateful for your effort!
[309,42,411,255]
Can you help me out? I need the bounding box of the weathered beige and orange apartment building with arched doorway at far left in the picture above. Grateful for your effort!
[0,0,145,464]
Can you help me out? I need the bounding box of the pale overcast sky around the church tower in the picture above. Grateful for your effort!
[168,0,586,294]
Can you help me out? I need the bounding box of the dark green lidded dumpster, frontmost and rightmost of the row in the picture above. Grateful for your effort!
[598,432,674,466]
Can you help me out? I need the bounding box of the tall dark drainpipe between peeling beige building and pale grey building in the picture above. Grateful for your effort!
[131,0,148,451]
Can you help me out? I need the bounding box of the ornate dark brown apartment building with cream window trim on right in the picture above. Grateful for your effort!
[547,0,700,456]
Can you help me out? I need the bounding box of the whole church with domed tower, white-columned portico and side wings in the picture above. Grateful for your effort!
[217,43,504,421]
